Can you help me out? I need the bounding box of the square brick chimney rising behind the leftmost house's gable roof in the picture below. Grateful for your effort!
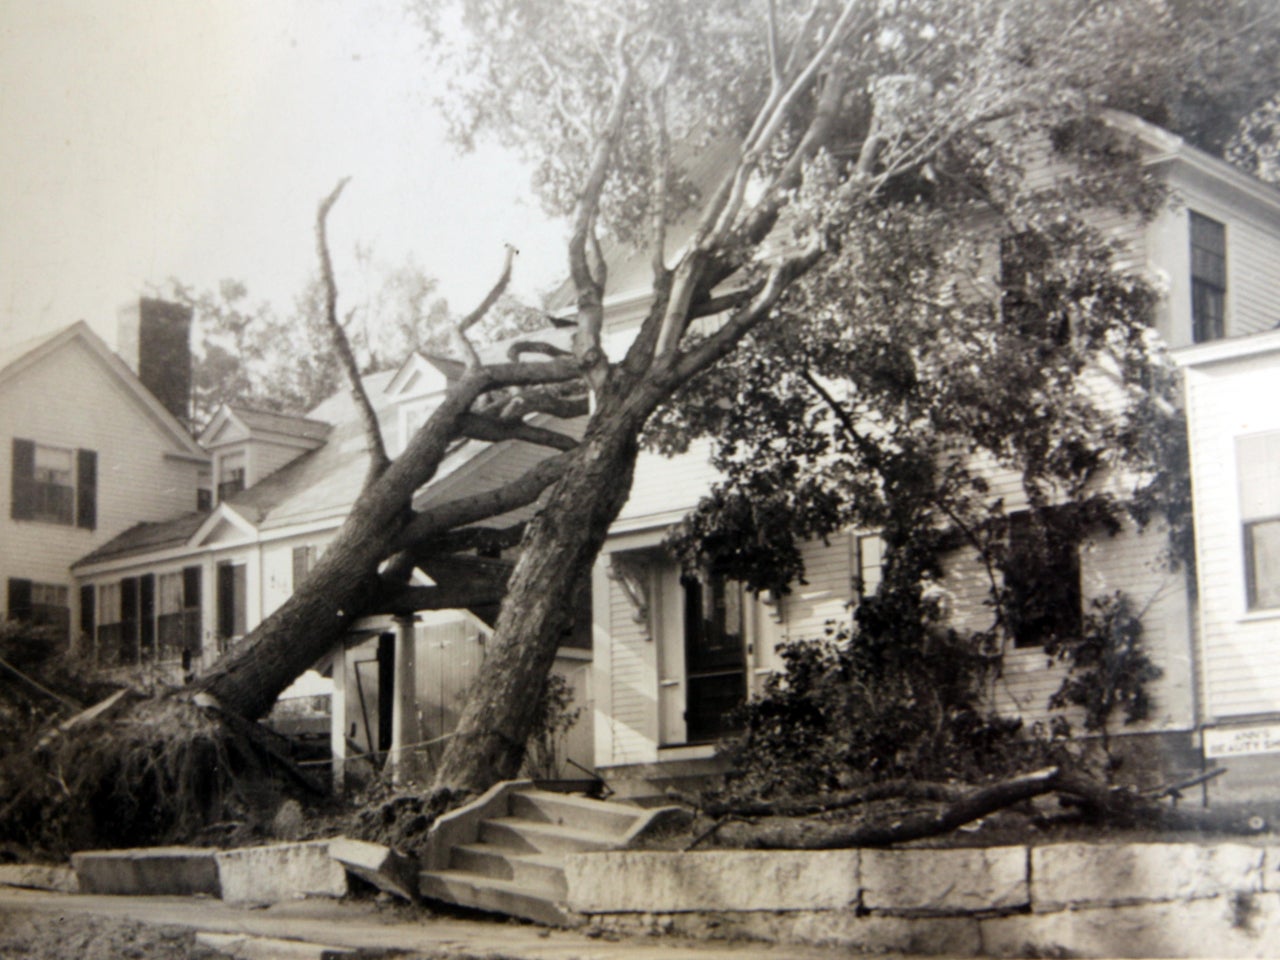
[116,297,191,426]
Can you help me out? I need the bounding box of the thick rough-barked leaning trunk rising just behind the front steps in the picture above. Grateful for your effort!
[435,398,652,792]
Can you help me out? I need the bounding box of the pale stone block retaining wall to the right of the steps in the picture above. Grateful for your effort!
[566,842,1280,957]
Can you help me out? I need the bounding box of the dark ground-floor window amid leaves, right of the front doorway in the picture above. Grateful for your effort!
[1004,511,1080,646]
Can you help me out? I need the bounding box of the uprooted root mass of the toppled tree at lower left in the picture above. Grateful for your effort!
[0,696,321,855]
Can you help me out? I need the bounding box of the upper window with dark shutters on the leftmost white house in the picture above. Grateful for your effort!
[10,438,97,530]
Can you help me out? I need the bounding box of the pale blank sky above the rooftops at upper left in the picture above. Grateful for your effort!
[0,0,564,346]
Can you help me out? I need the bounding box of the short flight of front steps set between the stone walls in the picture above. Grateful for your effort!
[419,783,655,927]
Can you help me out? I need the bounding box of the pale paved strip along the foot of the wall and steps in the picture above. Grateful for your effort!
[0,887,911,960]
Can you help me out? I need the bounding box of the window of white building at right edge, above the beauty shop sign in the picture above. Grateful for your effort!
[1235,433,1280,611]
